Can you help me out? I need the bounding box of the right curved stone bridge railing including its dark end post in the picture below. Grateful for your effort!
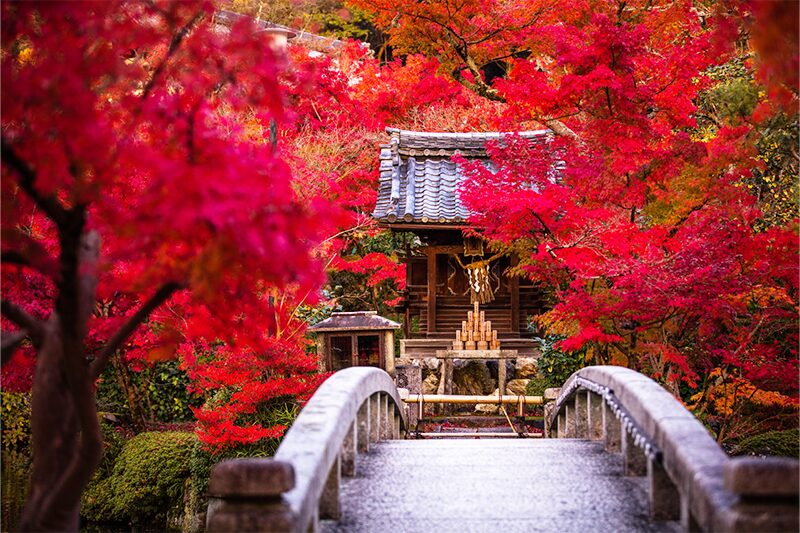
[545,366,800,531]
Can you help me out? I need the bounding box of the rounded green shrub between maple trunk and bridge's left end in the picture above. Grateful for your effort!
[81,431,197,524]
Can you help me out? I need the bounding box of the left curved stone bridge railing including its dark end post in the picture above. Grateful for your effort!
[206,367,407,533]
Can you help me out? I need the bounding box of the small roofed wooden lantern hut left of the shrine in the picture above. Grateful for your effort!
[308,311,400,377]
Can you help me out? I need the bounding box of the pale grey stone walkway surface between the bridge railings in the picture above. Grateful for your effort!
[321,439,680,533]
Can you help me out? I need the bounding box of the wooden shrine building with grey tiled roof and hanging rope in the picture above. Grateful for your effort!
[373,128,549,357]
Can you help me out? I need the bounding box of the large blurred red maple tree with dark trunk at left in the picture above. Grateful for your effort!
[2,2,324,531]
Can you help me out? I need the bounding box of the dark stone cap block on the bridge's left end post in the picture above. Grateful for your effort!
[208,458,295,498]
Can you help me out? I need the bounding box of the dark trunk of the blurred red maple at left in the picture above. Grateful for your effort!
[20,234,103,531]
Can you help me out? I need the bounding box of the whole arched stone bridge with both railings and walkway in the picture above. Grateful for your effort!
[208,366,799,533]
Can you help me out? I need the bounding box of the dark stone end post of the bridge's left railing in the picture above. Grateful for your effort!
[206,458,296,533]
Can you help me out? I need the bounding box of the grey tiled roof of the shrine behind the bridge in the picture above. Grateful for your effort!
[372,128,549,224]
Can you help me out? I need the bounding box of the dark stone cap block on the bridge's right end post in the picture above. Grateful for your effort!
[723,457,800,499]
